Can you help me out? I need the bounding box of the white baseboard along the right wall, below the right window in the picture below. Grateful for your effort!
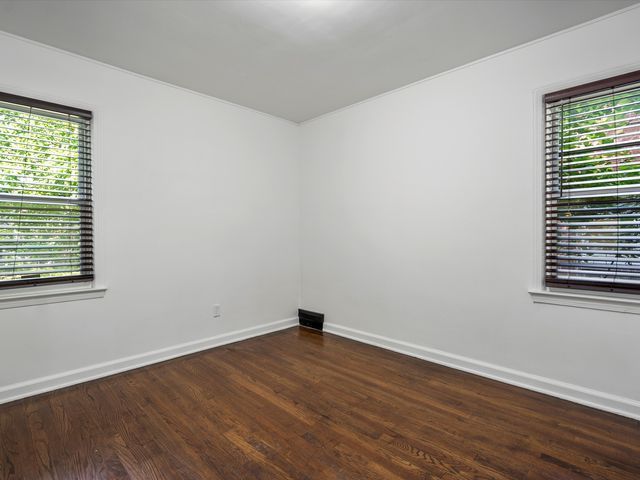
[324,323,640,420]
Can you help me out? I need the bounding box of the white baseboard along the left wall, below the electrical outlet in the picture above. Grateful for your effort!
[0,318,298,404]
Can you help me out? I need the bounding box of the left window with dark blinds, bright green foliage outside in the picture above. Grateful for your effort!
[0,93,93,288]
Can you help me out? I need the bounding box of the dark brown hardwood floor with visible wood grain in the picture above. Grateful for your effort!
[0,328,640,480]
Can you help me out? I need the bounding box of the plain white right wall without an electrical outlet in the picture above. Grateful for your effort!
[301,9,640,416]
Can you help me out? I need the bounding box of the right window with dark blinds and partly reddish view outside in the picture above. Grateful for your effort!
[544,71,640,293]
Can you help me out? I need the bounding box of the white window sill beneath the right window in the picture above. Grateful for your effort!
[529,289,640,314]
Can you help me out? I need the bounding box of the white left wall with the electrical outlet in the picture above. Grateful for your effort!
[0,34,300,401]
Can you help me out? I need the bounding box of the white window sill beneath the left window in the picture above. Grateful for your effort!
[0,286,107,310]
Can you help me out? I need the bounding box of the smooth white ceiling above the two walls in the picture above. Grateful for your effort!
[0,0,637,122]
